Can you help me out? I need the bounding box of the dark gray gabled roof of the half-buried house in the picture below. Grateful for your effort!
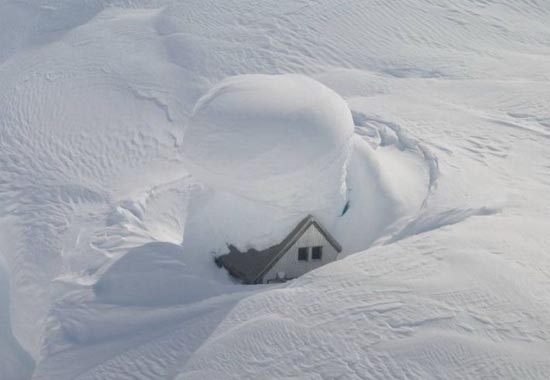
[216,215,342,284]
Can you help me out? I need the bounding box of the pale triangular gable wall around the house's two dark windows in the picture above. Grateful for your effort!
[263,225,338,283]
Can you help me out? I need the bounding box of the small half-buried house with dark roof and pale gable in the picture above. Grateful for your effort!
[216,215,342,284]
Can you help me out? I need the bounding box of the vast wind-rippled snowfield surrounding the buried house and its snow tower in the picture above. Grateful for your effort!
[0,0,550,380]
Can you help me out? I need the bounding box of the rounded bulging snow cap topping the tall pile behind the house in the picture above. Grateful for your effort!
[182,75,353,207]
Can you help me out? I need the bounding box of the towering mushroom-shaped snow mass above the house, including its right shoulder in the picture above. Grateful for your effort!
[181,75,427,258]
